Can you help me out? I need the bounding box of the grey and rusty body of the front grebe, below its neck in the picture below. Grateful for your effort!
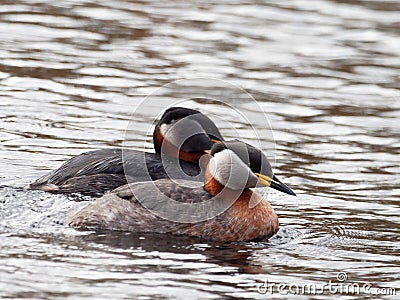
[69,179,279,242]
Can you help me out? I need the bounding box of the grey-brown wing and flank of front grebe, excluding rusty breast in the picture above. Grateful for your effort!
[70,179,223,233]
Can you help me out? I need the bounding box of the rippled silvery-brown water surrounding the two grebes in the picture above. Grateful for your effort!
[0,0,400,299]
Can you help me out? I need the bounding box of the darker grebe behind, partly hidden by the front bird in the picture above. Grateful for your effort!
[29,107,223,196]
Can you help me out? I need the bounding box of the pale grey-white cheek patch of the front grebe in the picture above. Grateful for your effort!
[209,149,258,190]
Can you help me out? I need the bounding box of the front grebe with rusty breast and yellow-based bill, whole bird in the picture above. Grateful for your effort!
[69,141,295,242]
